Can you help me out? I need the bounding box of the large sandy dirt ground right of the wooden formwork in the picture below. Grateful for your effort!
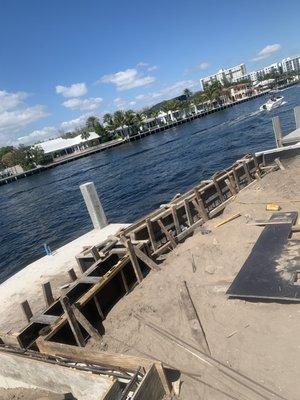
[90,157,300,400]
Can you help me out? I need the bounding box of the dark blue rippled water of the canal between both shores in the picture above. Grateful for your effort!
[0,86,300,281]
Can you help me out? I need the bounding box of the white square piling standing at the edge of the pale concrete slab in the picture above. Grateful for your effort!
[80,182,108,229]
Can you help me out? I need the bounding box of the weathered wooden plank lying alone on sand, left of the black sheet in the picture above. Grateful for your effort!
[179,281,211,355]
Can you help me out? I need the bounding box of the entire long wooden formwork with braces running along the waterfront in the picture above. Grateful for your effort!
[0,155,266,354]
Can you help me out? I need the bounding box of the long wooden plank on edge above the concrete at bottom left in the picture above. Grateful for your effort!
[37,337,154,372]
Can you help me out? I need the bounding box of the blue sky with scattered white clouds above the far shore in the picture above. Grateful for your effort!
[0,0,300,146]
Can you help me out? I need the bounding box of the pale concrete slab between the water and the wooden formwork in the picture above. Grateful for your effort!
[0,224,128,333]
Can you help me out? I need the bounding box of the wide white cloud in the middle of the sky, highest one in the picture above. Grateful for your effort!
[98,68,156,91]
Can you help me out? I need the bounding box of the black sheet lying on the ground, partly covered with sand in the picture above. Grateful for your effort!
[227,212,300,302]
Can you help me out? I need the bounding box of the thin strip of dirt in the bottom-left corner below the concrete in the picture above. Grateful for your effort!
[0,389,65,400]
